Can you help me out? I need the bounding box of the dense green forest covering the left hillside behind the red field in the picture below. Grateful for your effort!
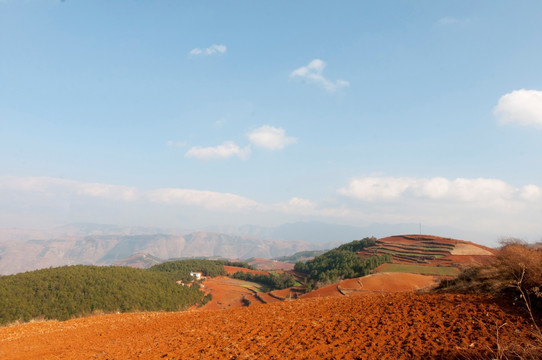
[0,260,224,325]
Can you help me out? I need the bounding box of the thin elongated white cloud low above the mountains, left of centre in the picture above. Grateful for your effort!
[147,188,258,210]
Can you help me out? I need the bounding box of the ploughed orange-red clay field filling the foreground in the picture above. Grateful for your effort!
[0,293,532,360]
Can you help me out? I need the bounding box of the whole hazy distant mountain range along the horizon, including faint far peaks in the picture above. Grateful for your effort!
[0,222,492,275]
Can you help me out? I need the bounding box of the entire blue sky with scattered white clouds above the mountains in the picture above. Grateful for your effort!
[0,0,542,242]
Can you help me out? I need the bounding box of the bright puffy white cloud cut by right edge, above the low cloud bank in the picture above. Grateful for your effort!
[493,89,542,128]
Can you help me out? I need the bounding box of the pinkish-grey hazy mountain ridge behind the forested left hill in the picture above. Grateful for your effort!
[0,226,338,275]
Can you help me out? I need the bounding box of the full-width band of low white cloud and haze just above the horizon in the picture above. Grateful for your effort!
[0,176,542,240]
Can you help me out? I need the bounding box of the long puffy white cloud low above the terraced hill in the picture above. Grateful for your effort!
[338,177,524,205]
